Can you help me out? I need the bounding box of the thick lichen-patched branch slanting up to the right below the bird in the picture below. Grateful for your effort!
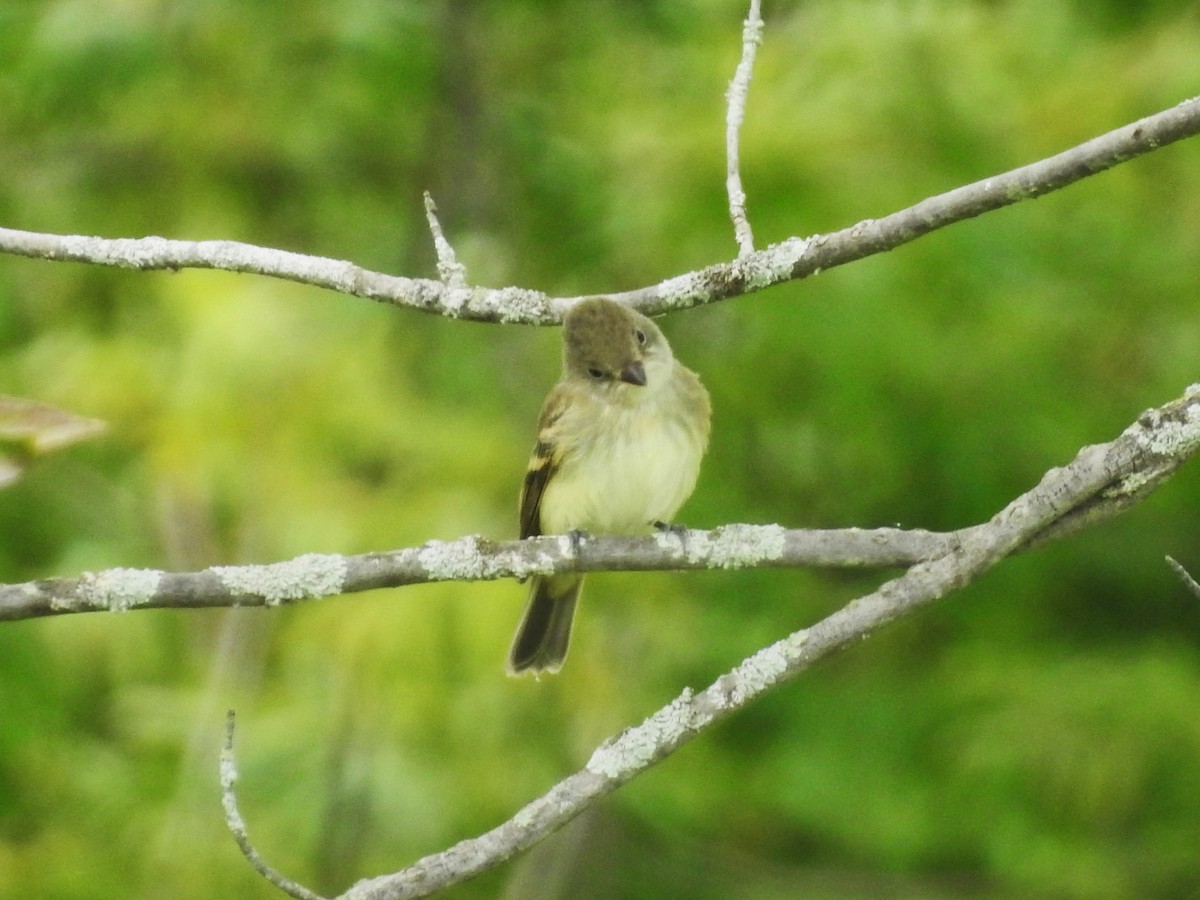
[324,386,1200,900]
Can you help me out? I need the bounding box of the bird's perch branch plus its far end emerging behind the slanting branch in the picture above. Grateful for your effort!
[11,384,1200,622]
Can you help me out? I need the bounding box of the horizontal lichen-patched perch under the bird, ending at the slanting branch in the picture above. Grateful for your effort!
[0,524,956,622]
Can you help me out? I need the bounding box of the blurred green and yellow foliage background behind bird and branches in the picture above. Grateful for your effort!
[0,0,1200,900]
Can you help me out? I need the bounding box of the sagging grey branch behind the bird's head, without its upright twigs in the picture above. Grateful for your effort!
[0,97,1200,325]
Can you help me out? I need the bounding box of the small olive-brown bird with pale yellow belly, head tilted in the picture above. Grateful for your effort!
[508,298,710,674]
